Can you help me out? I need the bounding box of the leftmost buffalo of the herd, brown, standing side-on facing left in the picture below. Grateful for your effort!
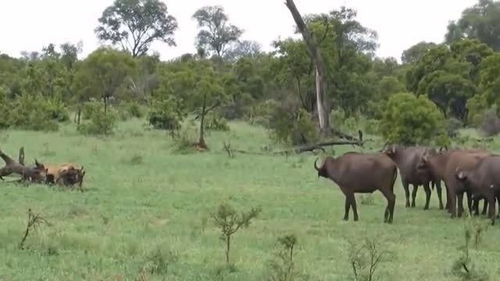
[314,153,397,223]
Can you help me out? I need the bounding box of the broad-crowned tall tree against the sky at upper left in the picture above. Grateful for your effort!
[95,0,177,57]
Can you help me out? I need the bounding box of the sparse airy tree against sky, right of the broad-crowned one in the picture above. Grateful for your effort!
[193,6,243,57]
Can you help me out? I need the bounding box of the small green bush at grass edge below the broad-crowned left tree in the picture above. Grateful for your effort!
[78,102,117,135]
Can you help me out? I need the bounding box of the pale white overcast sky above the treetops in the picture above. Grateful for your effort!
[0,0,477,59]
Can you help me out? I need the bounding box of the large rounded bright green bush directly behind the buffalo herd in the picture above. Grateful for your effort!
[380,93,449,145]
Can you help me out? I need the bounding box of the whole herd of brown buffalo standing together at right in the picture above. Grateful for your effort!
[314,145,500,224]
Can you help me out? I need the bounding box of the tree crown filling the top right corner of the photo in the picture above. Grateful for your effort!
[445,0,500,51]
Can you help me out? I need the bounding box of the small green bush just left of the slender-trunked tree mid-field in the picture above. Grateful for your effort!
[148,97,185,131]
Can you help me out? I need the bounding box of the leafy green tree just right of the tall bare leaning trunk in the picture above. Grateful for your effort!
[306,7,378,115]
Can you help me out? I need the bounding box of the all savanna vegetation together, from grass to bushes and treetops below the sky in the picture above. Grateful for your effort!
[0,0,500,281]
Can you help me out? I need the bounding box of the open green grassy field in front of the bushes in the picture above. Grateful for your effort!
[0,118,500,281]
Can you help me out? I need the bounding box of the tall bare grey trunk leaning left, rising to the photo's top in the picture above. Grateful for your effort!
[285,0,331,135]
